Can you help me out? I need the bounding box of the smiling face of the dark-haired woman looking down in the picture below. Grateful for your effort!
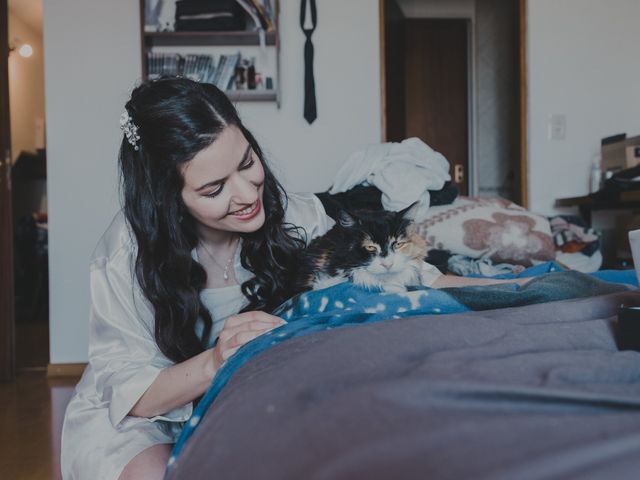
[181,126,265,236]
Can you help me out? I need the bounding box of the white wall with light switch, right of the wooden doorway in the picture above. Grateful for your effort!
[528,0,640,213]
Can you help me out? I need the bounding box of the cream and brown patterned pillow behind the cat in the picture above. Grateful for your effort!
[416,197,555,267]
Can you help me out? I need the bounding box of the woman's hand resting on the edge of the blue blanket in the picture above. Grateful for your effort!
[213,311,287,371]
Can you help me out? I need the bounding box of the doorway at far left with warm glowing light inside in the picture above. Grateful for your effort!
[0,0,49,380]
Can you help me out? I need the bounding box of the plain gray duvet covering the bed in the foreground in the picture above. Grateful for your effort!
[168,292,640,480]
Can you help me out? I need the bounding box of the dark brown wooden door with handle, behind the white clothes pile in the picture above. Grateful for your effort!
[380,0,470,195]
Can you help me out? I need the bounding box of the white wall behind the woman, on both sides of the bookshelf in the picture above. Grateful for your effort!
[44,0,381,363]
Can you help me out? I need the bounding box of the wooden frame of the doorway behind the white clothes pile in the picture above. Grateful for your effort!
[378,0,529,208]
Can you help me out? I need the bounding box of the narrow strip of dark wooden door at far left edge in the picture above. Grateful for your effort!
[0,0,15,381]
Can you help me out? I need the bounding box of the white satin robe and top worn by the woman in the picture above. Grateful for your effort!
[61,194,334,480]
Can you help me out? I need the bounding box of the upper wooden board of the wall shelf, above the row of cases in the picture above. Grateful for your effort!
[144,31,277,47]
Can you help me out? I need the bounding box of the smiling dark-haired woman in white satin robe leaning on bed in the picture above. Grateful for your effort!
[61,78,528,480]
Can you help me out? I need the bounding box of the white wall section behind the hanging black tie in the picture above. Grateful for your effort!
[238,0,381,192]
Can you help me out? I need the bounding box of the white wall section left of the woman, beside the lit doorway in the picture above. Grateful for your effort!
[44,0,141,363]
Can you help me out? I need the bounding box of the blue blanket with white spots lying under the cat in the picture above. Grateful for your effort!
[169,262,638,467]
